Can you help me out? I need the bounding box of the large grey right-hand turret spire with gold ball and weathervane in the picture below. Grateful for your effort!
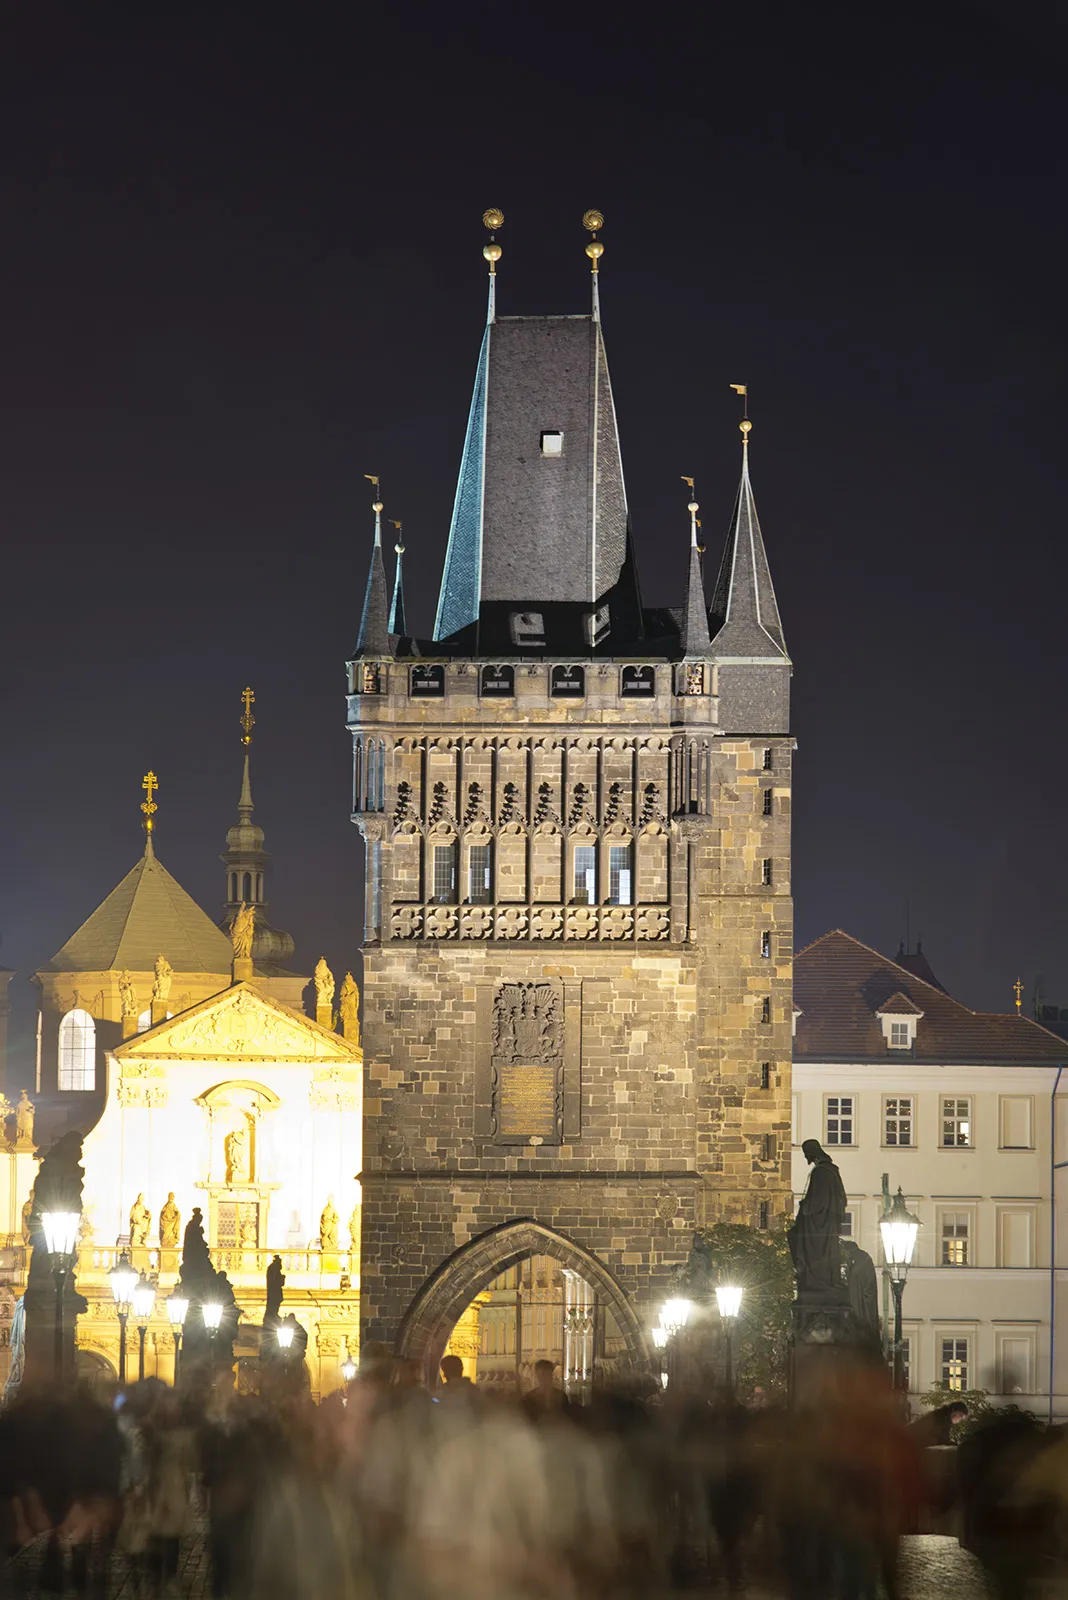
[711,403,787,661]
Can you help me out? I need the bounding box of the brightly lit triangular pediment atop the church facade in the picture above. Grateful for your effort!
[115,984,363,1066]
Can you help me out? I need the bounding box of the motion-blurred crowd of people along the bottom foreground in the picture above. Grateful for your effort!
[0,1350,1068,1600]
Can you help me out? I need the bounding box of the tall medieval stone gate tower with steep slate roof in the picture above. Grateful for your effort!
[349,213,791,1378]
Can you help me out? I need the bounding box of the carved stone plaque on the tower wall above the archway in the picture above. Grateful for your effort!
[491,982,564,1144]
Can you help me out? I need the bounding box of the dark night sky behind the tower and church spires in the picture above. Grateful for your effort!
[0,0,1068,1082]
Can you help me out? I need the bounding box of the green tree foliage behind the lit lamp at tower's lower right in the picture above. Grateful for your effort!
[679,1222,793,1397]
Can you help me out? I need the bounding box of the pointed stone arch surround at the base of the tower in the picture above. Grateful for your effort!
[397,1218,649,1386]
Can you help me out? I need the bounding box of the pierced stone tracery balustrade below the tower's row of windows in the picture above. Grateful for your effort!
[390,902,671,942]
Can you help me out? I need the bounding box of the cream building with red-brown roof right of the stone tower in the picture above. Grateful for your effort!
[793,931,1068,1416]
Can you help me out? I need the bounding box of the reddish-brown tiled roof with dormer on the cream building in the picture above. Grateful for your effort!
[793,928,1068,1066]
